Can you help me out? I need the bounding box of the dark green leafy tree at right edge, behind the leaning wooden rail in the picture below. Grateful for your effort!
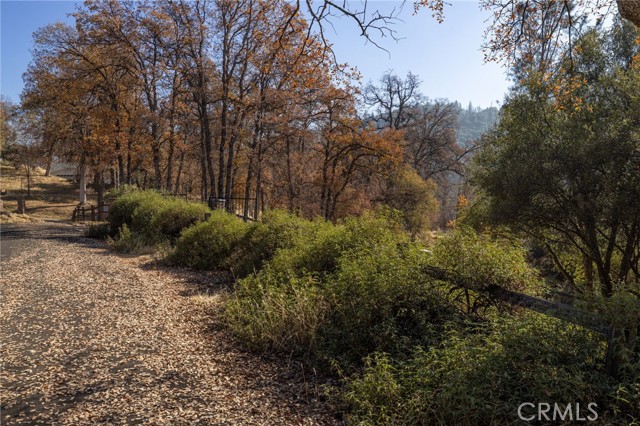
[476,26,640,297]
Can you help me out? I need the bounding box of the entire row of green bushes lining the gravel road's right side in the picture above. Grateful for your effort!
[105,196,640,425]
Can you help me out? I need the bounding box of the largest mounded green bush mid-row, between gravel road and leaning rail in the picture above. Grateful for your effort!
[227,212,456,367]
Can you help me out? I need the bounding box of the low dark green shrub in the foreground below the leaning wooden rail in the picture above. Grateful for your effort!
[340,315,611,425]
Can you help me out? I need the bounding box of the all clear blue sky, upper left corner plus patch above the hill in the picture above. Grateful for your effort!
[0,0,509,107]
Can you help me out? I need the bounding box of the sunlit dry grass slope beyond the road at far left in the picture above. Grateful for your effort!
[0,164,95,223]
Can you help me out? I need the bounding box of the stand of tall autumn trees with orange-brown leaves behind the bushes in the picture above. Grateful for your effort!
[11,0,496,229]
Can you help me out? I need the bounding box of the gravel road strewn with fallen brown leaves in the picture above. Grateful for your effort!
[0,221,338,425]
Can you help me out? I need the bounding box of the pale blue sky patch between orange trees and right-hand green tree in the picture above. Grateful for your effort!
[328,0,510,107]
